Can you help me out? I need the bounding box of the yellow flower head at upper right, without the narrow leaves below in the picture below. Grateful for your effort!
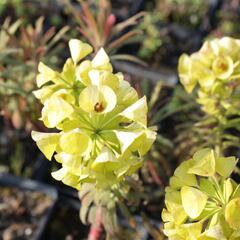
[178,37,240,118]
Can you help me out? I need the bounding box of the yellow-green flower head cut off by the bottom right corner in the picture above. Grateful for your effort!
[162,148,240,240]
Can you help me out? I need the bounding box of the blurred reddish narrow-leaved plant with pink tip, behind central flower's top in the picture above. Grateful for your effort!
[62,0,144,64]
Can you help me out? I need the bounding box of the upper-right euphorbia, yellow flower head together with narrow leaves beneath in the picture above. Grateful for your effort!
[178,37,240,157]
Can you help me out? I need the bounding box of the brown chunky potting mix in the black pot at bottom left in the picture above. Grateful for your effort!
[0,187,52,240]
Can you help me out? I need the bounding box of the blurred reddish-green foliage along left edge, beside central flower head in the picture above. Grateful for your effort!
[0,17,69,176]
